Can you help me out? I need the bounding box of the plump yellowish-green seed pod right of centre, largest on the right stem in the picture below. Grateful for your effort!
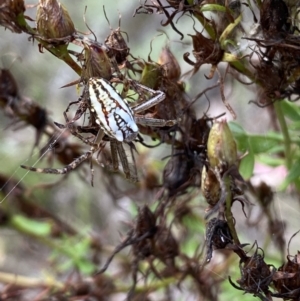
[207,120,237,169]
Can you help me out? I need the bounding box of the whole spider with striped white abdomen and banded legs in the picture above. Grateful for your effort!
[21,77,177,185]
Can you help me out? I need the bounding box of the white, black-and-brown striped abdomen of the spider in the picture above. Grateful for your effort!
[89,77,139,142]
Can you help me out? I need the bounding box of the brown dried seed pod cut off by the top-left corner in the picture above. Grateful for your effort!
[0,0,25,33]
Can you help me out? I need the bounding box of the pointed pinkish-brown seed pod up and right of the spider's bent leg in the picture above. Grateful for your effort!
[158,46,181,81]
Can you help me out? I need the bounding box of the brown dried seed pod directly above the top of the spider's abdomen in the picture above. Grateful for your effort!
[81,43,112,82]
